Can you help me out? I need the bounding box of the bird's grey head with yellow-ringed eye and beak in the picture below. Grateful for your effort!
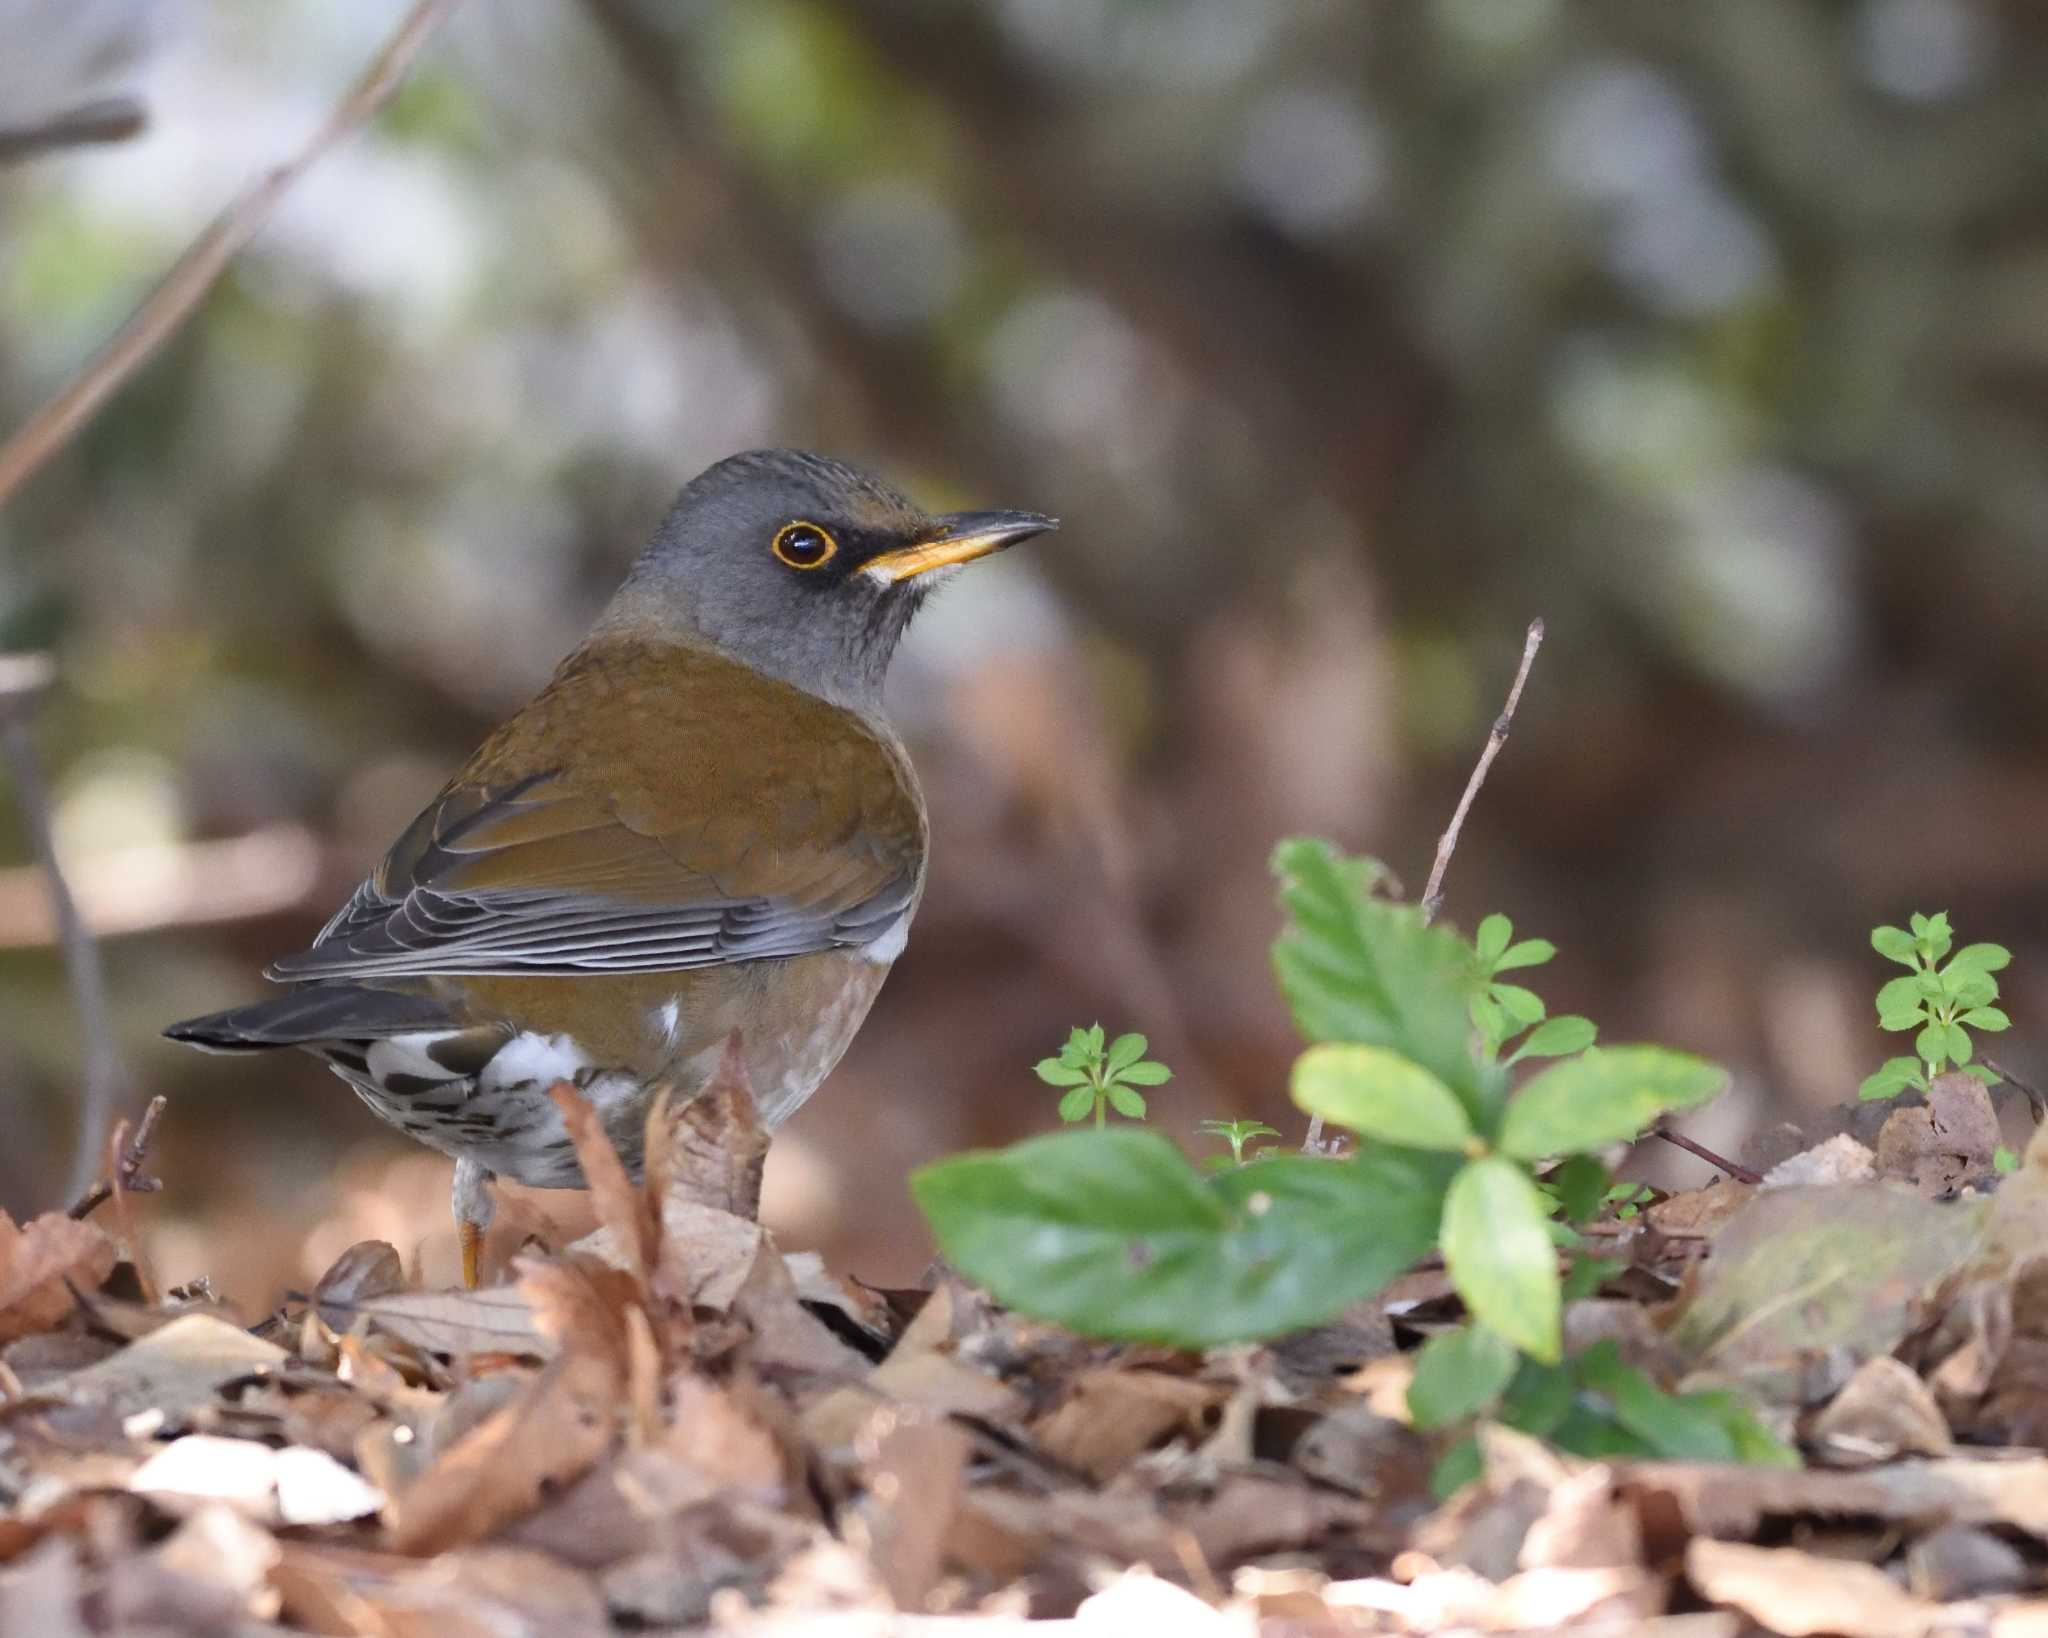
[604,448,1057,708]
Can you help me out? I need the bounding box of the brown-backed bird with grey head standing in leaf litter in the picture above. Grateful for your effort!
[166,450,1059,1288]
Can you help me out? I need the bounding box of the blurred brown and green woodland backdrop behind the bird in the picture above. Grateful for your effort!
[0,0,2048,1304]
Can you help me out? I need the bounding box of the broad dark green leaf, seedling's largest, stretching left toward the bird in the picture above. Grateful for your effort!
[911,1128,1452,1347]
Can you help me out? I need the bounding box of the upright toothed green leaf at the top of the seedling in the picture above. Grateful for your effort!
[1274,842,1505,1124]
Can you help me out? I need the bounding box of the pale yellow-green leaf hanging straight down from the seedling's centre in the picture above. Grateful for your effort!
[1444,1155,1563,1362]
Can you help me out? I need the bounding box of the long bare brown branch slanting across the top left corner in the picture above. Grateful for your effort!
[0,0,461,504]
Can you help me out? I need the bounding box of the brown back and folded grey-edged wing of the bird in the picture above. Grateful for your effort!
[270,645,926,981]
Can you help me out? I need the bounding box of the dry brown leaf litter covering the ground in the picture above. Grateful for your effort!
[19,1054,2048,1638]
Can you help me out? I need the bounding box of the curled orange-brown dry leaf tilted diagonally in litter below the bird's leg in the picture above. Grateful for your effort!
[391,1349,623,1554]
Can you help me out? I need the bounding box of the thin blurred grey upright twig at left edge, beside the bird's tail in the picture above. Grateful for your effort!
[0,653,127,1194]
